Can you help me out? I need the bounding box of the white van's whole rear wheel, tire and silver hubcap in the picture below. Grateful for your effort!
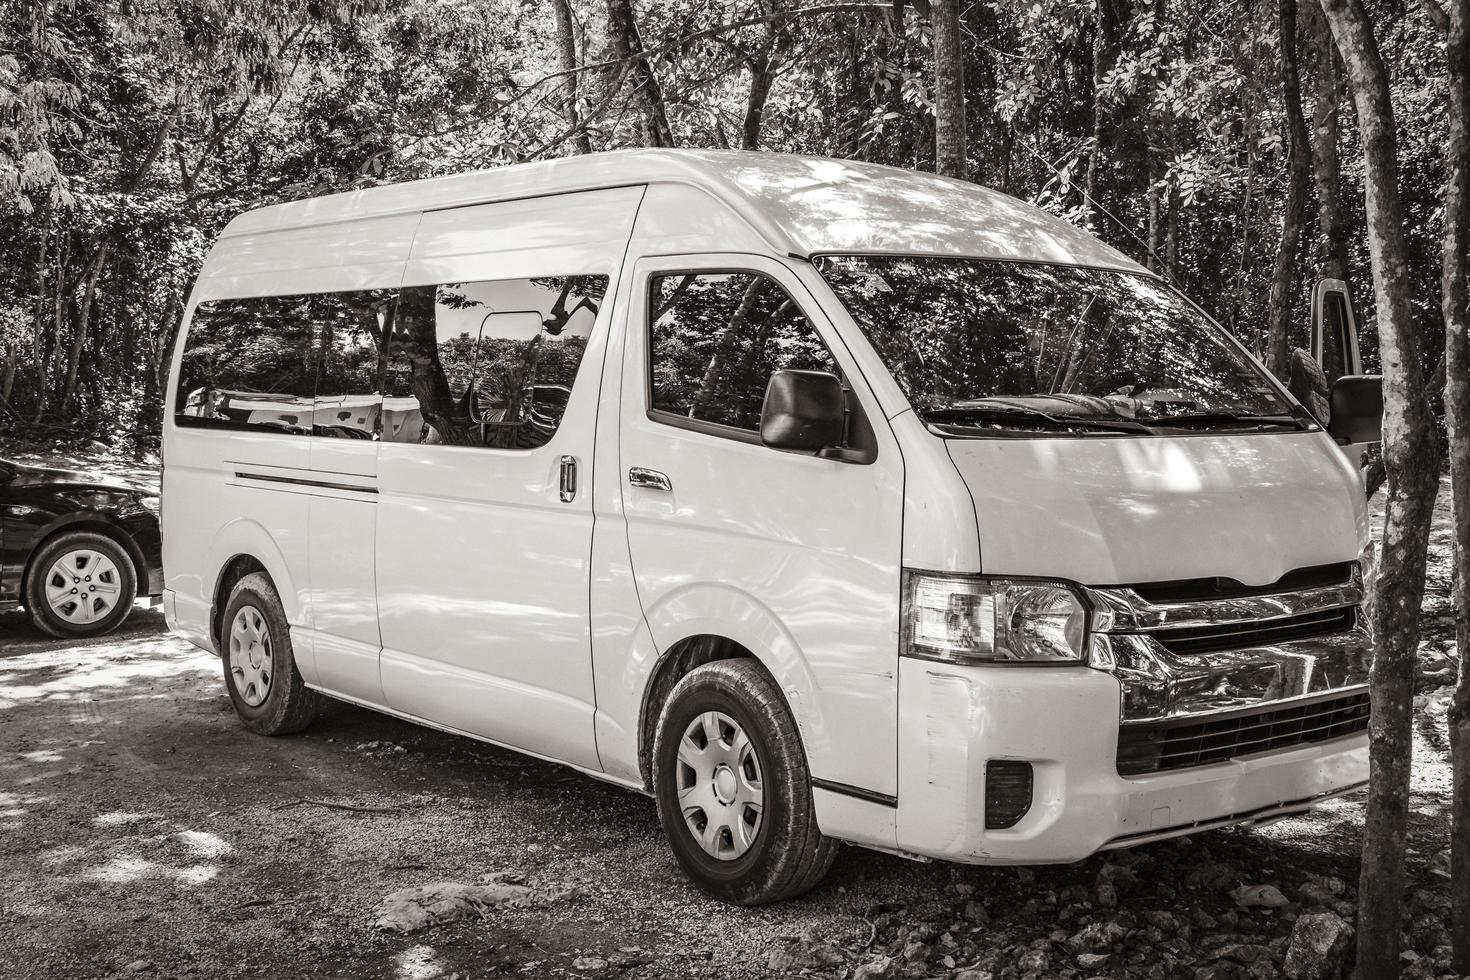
[219,572,320,735]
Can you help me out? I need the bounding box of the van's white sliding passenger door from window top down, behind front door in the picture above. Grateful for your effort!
[375,275,609,768]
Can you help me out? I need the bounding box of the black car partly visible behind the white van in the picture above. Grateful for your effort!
[0,460,163,636]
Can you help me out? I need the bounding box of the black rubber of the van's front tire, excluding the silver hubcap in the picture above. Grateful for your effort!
[653,660,838,905]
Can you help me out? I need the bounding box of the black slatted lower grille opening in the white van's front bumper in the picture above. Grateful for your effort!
[1117,691,1369,776]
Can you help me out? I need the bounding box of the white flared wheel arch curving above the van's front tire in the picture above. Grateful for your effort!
[644,582,831,776]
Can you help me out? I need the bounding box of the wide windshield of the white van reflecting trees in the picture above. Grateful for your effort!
[814,256,1305,435]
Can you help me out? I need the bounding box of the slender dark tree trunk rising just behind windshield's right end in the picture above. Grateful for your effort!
[1266,0,1311,378]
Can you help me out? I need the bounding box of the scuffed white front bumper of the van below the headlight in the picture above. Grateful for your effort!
[895,657,1369,864]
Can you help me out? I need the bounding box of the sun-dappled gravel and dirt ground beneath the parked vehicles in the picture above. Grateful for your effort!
[0,610,1444,980]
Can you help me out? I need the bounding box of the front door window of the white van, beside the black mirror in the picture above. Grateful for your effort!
[648,272,836,432]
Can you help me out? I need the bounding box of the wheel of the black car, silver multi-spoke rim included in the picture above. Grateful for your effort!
[25,530,138,639]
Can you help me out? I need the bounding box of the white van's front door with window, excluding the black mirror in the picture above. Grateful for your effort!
[617,254,904,799]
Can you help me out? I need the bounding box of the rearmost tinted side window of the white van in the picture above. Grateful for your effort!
[175,295,316,435]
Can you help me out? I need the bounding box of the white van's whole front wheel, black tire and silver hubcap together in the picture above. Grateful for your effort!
[653,660,838,905]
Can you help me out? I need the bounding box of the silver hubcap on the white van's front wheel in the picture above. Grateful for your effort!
[678,711,766,861]
